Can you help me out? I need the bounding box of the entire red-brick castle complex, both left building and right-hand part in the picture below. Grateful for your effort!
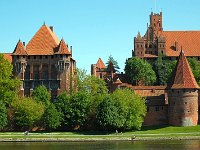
[4,12,200,126]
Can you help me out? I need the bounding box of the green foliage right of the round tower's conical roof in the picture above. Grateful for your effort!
[188,58,200,84]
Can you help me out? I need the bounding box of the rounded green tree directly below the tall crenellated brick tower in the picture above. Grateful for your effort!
[124,57,156,85]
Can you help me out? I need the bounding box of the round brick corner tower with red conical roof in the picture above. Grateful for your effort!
[168,51,199,126]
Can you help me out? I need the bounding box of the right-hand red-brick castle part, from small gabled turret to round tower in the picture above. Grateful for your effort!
[91,12,200,126]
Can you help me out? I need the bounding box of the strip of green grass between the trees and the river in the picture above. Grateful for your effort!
[0,126,200,140]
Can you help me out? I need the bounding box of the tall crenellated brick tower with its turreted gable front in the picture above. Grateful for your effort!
[132,12,166,58]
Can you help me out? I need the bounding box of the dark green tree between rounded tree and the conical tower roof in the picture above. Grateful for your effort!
[153,55,176,85]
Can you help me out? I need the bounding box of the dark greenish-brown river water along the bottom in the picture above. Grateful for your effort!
[0,140,200,150]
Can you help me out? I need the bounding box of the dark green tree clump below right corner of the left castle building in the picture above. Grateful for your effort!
[55,91,90,128]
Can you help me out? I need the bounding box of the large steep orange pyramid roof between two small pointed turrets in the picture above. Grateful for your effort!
[26,25,60,55]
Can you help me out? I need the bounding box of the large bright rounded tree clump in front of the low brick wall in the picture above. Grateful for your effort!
[97,89,146,130]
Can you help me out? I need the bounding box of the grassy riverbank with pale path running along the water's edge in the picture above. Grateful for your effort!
[0,126,200,142]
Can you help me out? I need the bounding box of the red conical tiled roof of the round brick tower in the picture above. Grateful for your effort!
[169,51,199,89]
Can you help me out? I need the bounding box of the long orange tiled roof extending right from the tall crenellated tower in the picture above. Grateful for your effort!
[160,31,200,56]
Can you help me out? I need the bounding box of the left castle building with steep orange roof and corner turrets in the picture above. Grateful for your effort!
[4,24,76,99]
